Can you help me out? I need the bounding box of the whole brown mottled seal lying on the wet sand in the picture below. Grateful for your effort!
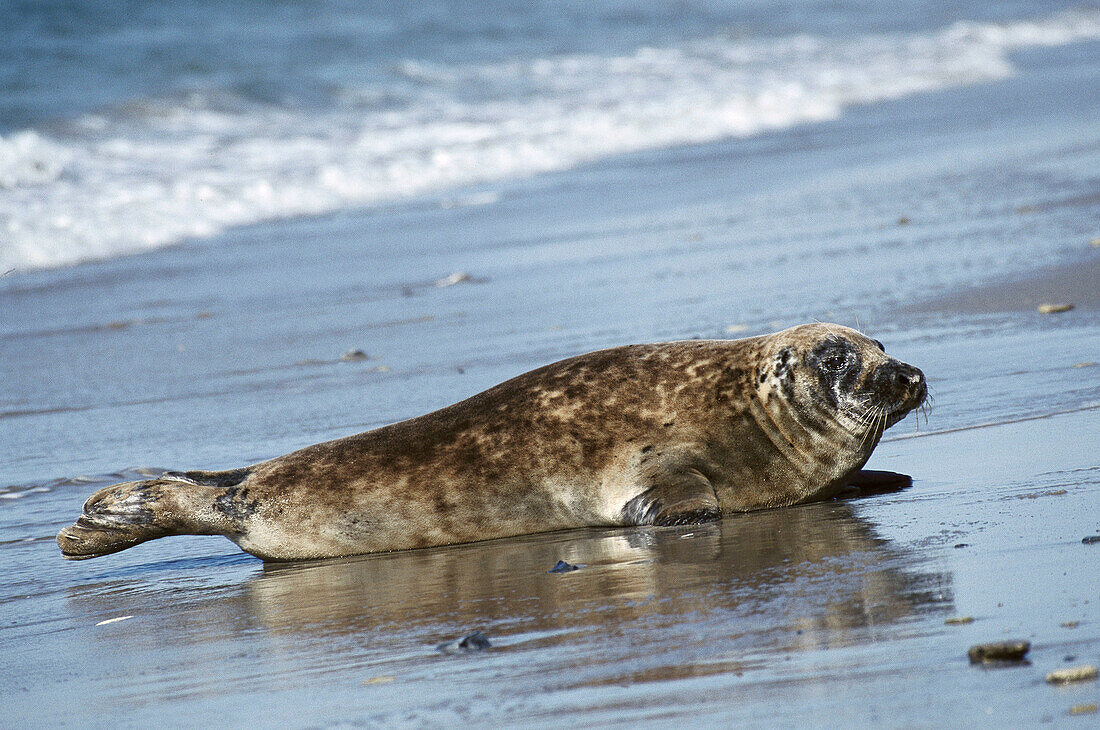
[57,324,926,560]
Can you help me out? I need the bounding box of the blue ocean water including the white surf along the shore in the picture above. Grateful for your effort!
[0,0,1100,270]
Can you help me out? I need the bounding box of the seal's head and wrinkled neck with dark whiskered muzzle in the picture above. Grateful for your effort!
[755,323,927,501]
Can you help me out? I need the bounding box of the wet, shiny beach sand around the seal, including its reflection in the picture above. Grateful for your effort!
[0,38,1100,727]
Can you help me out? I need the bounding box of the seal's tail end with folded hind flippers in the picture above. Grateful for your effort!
[57,473,247,561]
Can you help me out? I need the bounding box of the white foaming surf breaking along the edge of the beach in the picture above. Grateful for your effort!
[0,10,1100,269]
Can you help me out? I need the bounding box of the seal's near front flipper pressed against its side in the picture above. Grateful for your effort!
[623,468,722,526]
